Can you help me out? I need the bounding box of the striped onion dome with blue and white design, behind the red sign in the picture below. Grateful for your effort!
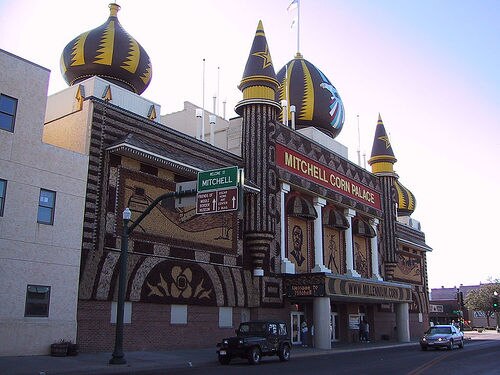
[277,52,345,138]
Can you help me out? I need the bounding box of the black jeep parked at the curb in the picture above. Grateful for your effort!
[217,320,292,365]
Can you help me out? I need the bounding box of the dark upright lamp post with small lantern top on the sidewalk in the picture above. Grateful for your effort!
[109,207,132,365]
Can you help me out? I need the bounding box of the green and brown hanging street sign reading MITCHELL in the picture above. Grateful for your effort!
[196,167,239,214]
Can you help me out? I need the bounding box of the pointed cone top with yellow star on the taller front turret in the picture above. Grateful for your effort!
[235,21,279,115]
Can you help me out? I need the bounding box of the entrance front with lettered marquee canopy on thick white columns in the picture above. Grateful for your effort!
[284,274,412,347]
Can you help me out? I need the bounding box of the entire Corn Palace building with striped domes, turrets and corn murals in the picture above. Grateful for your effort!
[37,4,431,351]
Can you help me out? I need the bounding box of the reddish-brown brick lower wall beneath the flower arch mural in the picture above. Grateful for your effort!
[77,300,290,352]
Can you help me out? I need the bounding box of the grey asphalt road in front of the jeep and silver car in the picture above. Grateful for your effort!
[163,339,500,375]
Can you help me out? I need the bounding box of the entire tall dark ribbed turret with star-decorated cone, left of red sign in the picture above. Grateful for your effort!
[235,21,280,277]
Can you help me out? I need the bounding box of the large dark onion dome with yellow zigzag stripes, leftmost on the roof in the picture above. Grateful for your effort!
[61,3,152,94]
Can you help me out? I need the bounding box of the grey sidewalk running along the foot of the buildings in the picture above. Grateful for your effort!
[0,341,416,375]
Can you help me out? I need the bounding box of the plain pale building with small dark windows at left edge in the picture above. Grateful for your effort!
[0,50,88,356]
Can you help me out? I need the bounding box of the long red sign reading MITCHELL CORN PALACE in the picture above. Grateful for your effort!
[276,144,381,210]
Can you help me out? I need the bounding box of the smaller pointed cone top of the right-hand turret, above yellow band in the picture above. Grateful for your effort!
[368,113,397,175]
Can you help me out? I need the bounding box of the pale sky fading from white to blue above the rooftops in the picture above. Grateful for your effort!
[0,0,500,288]
